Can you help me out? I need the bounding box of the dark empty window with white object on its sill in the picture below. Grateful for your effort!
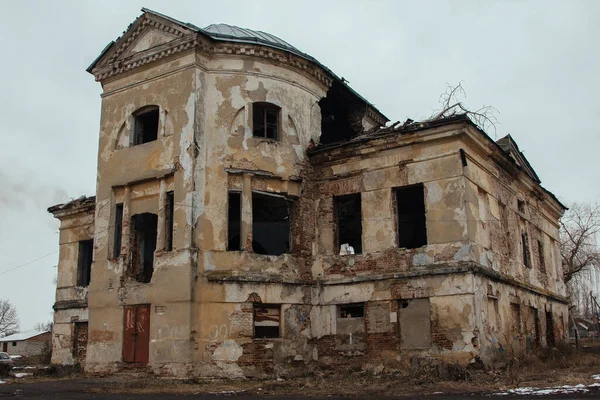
[334,193,362,254]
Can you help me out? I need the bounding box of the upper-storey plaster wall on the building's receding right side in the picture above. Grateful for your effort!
[464,133,566,296]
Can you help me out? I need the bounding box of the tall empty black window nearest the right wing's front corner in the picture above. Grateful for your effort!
[396,184,427,249]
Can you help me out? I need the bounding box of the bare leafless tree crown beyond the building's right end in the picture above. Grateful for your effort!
[560,203,600,283]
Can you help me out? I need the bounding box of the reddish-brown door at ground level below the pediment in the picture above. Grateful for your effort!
[123,304,150,364]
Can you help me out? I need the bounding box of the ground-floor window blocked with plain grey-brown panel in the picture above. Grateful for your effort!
[398,297,431,349]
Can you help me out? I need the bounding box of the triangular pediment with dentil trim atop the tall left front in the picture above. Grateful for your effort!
[88,9,197,80]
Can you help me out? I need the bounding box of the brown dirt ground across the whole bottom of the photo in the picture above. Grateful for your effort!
[0,347,600,398]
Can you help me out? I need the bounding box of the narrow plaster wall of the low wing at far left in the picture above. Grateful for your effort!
[52,210,94,365]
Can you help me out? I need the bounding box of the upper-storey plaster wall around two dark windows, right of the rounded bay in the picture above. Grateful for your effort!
[312,132,471,279]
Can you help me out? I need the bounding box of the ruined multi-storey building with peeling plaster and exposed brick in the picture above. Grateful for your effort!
[49,9,567,377]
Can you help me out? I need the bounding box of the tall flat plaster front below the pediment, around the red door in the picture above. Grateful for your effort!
[86,53,202,375]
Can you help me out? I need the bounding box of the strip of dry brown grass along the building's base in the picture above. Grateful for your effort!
[61,350,600,396]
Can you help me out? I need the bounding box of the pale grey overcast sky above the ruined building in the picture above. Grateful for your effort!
[0,0,600,330]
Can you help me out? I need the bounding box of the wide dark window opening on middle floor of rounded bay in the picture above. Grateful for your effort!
[252,192,290,256]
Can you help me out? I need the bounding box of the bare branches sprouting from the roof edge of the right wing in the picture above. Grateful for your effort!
[429,81,499,136]
